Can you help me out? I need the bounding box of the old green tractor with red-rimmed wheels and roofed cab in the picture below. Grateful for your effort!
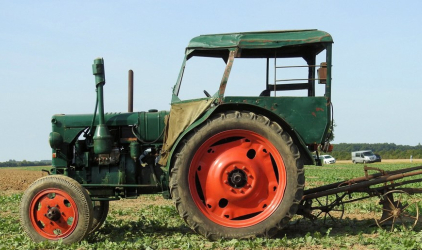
[20,30,333,243]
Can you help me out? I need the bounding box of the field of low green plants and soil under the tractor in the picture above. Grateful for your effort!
[0,161,422,250]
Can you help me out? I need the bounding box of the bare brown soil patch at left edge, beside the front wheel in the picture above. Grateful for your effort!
[0,168,47,195]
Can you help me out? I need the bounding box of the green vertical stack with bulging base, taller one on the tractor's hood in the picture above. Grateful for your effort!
[92,58,112,154]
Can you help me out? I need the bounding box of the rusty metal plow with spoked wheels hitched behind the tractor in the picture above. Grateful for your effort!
[297,166,422,231]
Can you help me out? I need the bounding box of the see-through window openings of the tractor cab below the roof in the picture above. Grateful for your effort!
[175,50,326,100]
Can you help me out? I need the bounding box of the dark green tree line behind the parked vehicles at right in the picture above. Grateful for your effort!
[330,143,422,160]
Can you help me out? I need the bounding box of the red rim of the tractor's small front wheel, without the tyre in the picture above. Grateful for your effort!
[29,188,78,240]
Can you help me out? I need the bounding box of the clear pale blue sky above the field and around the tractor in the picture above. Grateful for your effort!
[0,0,422,161]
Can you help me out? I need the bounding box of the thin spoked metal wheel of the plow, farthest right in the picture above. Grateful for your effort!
[375,190,419,232]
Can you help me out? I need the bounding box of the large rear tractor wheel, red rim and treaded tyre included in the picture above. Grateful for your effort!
[170,111,304,239]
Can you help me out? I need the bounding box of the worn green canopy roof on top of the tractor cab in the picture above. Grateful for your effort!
[187,29,333,49]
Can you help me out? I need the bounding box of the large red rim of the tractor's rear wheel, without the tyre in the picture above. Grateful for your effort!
[188,129,286,228]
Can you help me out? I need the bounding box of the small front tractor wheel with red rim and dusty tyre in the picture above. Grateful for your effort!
[20,175,92,244]
